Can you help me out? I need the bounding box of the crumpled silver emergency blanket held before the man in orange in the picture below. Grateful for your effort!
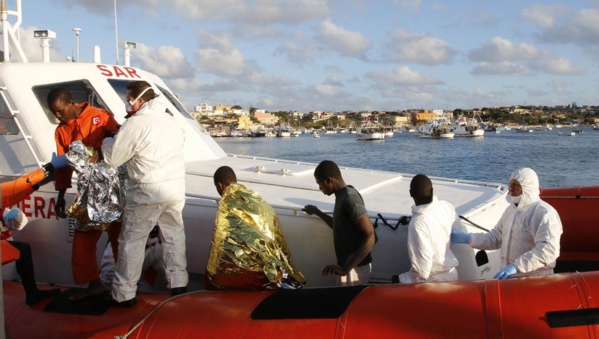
[67,140,127,231]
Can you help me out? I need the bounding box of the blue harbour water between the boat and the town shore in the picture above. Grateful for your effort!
[215,127,599,187]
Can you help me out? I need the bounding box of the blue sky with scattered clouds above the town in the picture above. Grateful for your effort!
[7,0,599,113]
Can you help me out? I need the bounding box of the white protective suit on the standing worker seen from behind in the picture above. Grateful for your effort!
[102,96,188,302]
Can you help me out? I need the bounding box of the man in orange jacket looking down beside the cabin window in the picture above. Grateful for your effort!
[48,88,121,301]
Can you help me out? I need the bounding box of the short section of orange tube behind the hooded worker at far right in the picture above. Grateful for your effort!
[541,186,599,261]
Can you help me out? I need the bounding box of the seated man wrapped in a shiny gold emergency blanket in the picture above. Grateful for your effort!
[207,166,306,290]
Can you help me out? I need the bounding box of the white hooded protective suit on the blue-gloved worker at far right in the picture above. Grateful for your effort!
[470,168,562,277]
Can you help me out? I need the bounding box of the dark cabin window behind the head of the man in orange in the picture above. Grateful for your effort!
[33,80,110,125]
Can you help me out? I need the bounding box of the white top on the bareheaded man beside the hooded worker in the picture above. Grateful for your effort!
[399,196,460,284]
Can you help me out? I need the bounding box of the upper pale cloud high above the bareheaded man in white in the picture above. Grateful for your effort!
[384,29,456,66]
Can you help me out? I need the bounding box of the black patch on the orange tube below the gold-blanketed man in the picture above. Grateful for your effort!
[252,285,368,320]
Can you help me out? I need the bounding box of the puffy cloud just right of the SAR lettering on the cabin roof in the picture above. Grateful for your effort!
[133,43,194,78]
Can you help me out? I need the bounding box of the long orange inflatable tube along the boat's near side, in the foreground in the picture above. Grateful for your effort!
[4,272,599,339]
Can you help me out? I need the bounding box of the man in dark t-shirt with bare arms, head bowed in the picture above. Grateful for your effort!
[303,160,375,286]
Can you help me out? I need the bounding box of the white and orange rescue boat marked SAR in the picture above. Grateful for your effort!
[0,0,599,338]
